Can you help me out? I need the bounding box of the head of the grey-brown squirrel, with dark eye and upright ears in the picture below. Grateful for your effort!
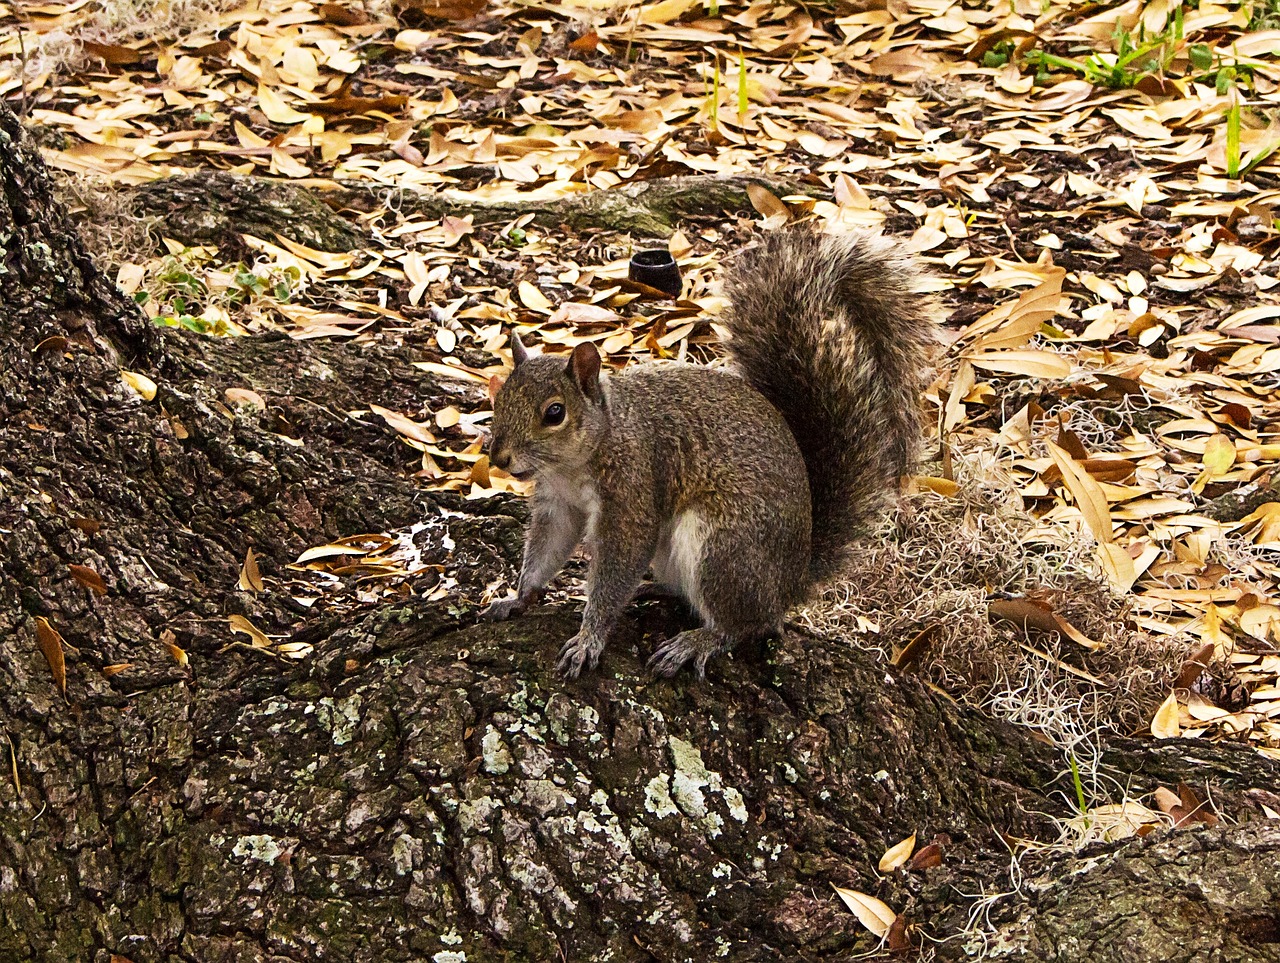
[489,334,604,478]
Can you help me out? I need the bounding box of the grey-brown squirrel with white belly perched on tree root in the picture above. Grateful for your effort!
[484,228,936,679]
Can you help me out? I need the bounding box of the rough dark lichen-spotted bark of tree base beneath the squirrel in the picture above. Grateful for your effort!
[0,106,1280,963]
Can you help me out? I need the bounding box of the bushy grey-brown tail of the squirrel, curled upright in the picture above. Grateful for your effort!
[724,229,936,579]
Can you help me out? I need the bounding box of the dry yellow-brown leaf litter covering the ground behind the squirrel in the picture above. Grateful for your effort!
[10,0,1280,758]
